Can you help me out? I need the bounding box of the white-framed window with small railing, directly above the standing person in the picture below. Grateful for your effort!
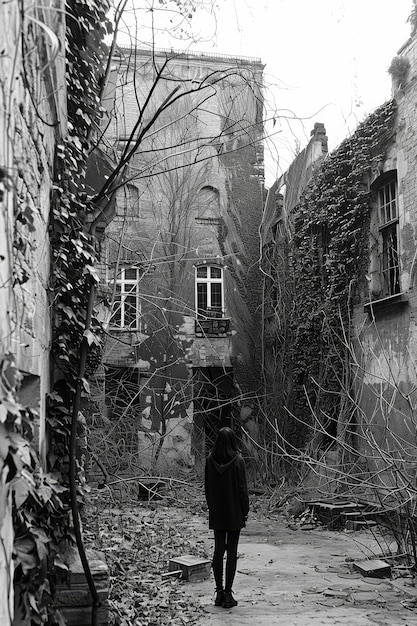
[195,265,224,317]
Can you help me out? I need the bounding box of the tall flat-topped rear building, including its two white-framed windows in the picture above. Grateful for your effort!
[96,48,263,468]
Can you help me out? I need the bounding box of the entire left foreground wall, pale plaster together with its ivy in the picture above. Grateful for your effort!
[0,1,109,626]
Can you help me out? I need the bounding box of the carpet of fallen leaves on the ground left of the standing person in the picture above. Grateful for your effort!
[84,492,208,626]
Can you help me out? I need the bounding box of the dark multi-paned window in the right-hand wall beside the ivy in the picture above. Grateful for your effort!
[378,179,400,296]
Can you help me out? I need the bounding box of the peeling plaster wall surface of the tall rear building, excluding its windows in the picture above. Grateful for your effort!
[100,49,263,465]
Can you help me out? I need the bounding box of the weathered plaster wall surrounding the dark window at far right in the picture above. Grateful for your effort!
[353,31,417,468]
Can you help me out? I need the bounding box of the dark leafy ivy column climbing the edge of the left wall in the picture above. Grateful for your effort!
[49,0,111,454]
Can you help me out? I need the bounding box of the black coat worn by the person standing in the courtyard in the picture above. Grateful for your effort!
[204,454,249,530]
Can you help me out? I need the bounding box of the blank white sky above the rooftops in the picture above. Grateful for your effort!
[116,0,412,186]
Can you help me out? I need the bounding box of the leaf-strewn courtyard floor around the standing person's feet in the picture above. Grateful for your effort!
[85,482,417,626]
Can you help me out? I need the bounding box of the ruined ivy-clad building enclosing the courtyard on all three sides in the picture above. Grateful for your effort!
[0,0,417,626]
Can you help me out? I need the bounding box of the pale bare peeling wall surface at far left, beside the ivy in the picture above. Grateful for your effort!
[0,0,66,626]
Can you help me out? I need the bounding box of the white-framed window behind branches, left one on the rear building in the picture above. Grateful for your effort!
[110,267,141,330]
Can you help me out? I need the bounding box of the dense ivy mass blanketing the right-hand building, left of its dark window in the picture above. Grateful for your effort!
[266,101,396,449]
